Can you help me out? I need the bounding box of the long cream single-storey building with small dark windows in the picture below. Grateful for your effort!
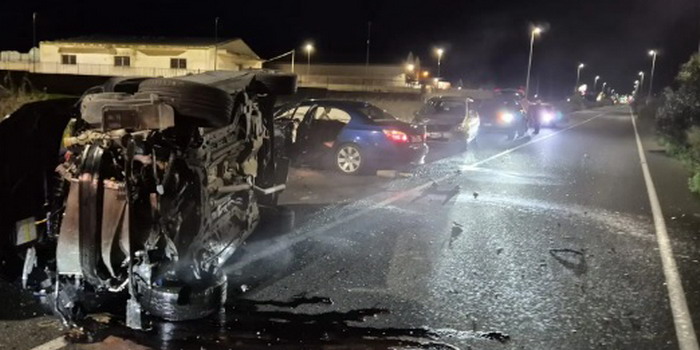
[0,36,263,77]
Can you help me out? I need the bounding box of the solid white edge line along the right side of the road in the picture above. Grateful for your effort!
[630,111,700,350]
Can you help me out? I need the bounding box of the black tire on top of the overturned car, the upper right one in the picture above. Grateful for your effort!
[139,78,233,127]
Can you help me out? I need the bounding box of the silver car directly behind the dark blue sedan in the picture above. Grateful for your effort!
[414,96,480,150]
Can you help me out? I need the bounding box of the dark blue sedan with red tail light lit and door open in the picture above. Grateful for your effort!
[275,100,428,174]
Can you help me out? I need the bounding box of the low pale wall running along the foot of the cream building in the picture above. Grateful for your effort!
[0,61,202,77]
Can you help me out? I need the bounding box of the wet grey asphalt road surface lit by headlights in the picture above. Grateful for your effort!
[0,107,700,349]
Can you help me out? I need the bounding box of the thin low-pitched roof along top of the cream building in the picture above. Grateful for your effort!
[48,35,240,46]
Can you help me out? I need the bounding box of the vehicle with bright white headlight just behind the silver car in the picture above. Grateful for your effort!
[478,96,528,139]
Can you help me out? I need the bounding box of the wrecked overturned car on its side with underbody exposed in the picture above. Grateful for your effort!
[0,71,296,328]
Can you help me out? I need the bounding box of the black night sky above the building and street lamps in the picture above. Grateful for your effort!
[0,0,700,95]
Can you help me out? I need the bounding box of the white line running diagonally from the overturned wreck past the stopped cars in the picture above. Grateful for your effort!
[232,113,605,271]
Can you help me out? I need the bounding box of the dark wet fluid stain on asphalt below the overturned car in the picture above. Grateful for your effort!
[60,295,510,350]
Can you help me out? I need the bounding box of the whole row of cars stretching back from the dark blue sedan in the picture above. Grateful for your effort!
[275,91,564,175]
